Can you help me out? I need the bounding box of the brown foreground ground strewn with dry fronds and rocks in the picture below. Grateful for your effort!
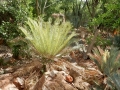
[0,47,103,90]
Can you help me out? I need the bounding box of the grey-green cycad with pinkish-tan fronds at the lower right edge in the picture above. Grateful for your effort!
[89,47,120,90]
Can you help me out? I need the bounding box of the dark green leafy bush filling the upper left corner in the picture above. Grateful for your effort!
[0,0,32,40]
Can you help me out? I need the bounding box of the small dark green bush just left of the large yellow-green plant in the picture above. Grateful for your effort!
[7,37,31,59]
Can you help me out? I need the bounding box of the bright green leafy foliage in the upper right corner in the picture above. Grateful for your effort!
[91,0,120,31]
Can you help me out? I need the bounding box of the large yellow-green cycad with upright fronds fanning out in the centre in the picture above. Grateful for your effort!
[19,18,76,58]
